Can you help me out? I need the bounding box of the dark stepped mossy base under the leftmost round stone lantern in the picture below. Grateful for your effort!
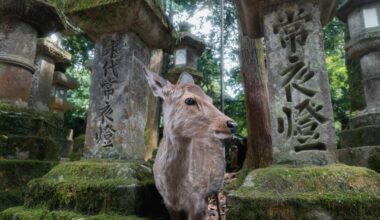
[0,103,67,160]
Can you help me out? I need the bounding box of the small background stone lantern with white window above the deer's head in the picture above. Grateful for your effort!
[168,22,205,83]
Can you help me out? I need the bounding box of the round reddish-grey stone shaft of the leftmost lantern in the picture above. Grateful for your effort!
[0,19,37,102]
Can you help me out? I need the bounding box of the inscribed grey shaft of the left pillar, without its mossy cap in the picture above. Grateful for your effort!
[86,32,150,159]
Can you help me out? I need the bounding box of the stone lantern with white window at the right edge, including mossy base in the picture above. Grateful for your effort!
[338,0,380,171]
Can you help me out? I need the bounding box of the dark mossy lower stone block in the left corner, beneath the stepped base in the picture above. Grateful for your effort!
[0,159,57,211]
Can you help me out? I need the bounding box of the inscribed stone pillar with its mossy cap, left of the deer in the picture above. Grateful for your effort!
[58,0,174,159]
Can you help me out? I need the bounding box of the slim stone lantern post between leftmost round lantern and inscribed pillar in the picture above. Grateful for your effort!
[28,38,71,111]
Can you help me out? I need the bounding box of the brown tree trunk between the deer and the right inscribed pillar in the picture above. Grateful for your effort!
[240,35,272,172]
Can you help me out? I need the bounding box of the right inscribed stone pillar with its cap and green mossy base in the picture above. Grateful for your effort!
[227,0,380,220]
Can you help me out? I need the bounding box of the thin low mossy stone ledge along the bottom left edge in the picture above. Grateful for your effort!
[0,207,145,220]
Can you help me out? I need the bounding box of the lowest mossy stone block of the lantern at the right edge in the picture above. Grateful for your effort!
[338,146,380,173]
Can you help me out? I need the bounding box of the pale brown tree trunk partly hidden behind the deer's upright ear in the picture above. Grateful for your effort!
[144,50,163,161]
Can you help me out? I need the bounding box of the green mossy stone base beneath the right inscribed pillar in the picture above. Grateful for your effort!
[227,165,380,220]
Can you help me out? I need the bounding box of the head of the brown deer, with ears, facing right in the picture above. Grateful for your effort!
[144,68,237,139]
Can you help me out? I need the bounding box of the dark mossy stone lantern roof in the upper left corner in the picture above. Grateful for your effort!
[0,0,66,36]
